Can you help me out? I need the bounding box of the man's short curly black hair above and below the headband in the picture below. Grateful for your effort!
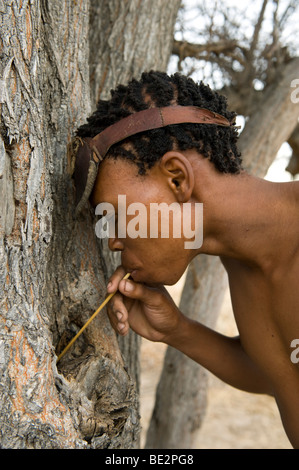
[77,71,242,174]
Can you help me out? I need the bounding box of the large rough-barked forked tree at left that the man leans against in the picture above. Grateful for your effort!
[0,0,179,448]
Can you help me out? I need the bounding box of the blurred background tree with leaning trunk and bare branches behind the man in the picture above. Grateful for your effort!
[146,0,299,448]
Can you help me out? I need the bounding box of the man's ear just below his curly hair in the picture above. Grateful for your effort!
[160,150,194,202]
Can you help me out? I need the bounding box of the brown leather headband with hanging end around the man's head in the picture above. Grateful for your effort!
[70,106,232,214]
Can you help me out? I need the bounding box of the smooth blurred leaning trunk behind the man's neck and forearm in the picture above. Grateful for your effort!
[146,58,299,449]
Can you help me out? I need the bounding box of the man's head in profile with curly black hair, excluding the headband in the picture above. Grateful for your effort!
[77,72,241,284]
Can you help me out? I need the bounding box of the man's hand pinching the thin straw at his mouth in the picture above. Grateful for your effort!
[107,266,184,343]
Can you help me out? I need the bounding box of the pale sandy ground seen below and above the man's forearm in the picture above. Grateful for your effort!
[140,284,292,449]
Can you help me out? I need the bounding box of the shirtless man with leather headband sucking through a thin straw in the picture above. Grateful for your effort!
[77,72,299,447]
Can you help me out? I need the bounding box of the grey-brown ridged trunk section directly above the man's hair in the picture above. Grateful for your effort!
[89,0,180,103]
